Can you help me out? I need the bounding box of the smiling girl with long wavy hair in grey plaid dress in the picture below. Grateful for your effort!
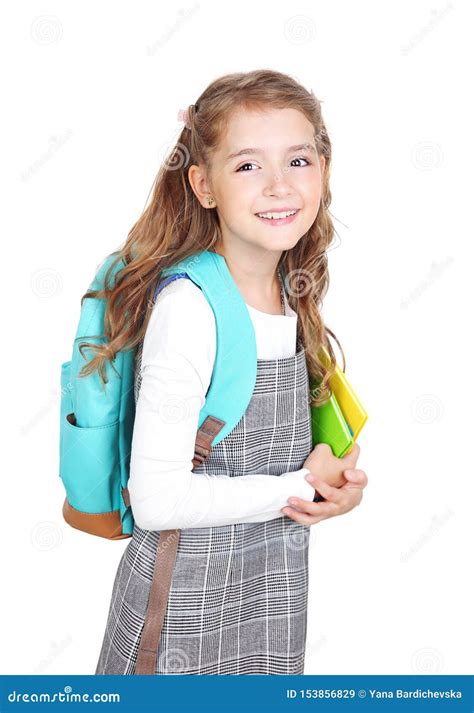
[88,70,367,674]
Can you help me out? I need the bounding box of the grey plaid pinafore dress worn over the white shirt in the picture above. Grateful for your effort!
[95,328,312,674]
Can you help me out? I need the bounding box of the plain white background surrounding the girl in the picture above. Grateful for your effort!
[0,0,474,674]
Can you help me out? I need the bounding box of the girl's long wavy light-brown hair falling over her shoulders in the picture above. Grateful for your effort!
[80,69,345,406]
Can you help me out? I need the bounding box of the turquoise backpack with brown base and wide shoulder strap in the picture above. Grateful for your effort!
[59,250,257,540]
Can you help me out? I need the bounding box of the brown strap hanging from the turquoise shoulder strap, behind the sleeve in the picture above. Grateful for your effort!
[134,416,225,675]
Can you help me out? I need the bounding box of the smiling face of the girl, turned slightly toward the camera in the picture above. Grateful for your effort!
[189,108,325,254]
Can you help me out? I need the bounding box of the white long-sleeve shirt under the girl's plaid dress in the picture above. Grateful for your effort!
[128,278,315,530]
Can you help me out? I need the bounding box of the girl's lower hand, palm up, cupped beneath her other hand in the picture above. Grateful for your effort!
[281,469,369,525]
